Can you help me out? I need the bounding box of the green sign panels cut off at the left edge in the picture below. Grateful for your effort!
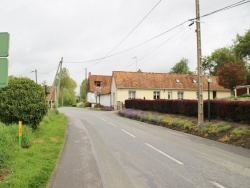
[0,32,10,88]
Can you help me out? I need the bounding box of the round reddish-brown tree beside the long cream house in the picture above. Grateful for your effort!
[217,62,246,93]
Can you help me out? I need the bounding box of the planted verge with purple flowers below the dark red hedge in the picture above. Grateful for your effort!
[118,109,250,149]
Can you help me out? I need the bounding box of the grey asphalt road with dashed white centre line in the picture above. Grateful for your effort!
[48,108,250,188]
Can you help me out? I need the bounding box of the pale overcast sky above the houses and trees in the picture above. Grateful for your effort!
[0,0,250,93]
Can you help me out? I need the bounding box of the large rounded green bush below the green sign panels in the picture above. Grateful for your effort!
[0,77,48,129]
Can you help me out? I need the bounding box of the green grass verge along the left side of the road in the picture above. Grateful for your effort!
[0,111,67,188]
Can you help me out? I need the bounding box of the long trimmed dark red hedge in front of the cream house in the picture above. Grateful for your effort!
[125,99,250,123]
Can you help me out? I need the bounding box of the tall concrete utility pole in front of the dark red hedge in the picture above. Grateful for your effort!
[195,0,204,127]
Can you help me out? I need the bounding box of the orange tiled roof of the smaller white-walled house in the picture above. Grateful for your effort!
[89,75,112,94]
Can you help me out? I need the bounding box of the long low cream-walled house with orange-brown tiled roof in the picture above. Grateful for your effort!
[111,71,231,109]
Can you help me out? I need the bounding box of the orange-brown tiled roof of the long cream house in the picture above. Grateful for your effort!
[113,71,228,90]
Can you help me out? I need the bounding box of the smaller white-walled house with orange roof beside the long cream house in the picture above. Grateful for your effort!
[87,73,112,107]
